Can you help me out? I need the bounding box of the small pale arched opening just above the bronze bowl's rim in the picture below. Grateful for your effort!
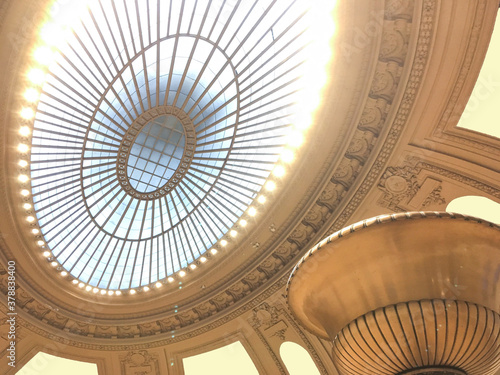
[446,195,500,224]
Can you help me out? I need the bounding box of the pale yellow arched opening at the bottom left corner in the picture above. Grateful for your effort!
[17,351,98,375]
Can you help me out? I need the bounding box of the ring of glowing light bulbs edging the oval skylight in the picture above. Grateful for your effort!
[17,1,334,296]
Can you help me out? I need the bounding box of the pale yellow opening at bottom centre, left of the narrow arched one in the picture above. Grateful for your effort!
[186,341,259,375]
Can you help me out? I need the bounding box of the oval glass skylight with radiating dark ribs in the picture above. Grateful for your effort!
[31,0,330,290]
